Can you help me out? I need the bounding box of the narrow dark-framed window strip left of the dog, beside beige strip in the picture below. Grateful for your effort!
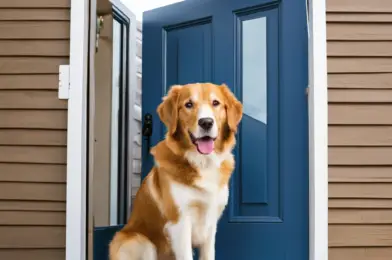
[110,8,130,225]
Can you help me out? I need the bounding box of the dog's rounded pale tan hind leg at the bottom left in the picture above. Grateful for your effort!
[109,231,157,260]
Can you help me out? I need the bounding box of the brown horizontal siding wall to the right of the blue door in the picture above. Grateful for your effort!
[327,0,392,260]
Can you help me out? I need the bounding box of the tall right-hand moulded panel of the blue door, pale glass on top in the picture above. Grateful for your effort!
[230,9,281,222]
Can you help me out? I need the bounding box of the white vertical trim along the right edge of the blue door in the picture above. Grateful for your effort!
[308,0,328,260]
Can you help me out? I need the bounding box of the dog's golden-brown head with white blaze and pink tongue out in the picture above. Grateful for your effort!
[157,83,242,155]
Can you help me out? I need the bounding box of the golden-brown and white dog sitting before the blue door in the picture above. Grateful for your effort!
[109,83,242,260]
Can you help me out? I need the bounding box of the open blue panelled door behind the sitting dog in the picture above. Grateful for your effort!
[142,0,309,260]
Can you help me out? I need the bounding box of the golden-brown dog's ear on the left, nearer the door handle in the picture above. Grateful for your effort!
[157,85,182,135]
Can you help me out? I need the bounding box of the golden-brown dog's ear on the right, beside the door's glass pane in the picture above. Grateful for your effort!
[220,84,242,133]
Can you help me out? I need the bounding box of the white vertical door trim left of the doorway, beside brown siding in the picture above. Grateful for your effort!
[65,0,89,260]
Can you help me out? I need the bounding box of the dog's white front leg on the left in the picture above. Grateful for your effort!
[166,216,193,260]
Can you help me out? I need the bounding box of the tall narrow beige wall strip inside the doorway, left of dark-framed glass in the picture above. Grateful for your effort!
[93,15,113,226]
